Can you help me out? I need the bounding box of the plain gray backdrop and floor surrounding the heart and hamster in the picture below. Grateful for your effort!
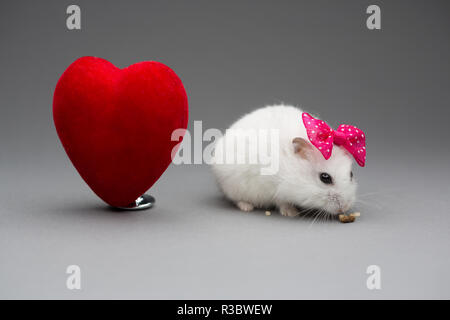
[0,0,450,299]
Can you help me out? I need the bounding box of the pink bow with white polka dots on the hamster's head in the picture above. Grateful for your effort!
[302,112,366,167]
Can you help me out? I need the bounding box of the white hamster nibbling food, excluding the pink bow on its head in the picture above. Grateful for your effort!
[212,105,357,216]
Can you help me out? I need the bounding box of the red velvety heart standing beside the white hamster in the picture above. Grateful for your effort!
[53,57,188,206]
